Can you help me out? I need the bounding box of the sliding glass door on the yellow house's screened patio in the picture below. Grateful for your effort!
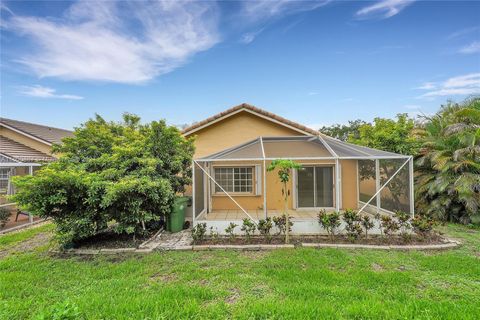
[297,166,333,208]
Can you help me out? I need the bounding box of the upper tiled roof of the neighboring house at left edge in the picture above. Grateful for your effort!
[0,118,73,145]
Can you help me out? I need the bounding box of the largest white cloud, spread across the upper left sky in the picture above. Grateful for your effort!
[5,0,219,83]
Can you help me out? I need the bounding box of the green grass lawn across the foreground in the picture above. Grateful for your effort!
[0,225,480,319]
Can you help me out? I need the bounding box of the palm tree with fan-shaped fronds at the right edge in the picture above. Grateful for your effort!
[416,97,480,223]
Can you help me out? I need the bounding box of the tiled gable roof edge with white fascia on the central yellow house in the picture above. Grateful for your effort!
[182,102,318,135]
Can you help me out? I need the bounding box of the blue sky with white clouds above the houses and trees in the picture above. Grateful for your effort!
[0,0,480,129]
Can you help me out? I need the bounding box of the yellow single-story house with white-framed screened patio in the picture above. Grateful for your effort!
[183,104,414,233]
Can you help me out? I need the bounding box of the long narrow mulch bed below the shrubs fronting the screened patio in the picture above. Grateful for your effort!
[195,234,445,245]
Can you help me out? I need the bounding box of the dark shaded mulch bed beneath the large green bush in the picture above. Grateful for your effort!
[73,231,154,249]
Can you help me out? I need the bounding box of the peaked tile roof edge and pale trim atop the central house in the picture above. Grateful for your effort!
[182,103,318,135]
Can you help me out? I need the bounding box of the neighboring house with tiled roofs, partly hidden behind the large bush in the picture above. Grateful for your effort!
[0,118,72,228]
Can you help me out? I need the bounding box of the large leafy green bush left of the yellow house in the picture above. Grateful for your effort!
[9,114,194,241]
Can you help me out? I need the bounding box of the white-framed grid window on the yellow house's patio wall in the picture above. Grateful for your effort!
[214,167,253,193]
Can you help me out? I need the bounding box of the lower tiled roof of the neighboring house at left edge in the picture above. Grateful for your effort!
[0,136,55,162]
